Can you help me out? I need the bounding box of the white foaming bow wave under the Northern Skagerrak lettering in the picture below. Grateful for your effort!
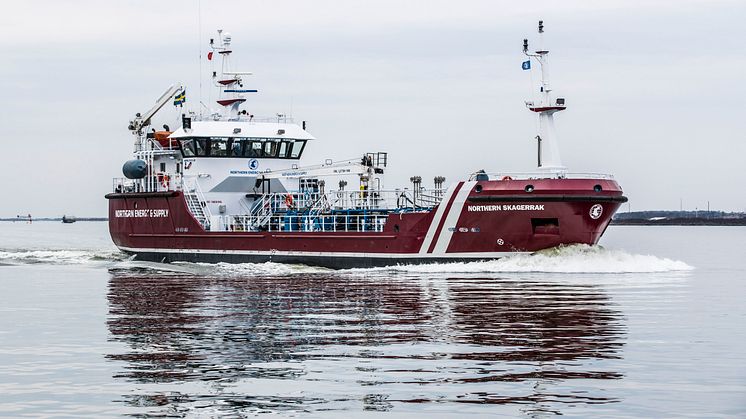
[348,245,694,274]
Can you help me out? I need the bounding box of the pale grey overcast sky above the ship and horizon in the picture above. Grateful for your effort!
[0,0,746,216]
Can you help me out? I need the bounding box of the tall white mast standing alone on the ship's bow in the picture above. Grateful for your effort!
[523,20,567,176]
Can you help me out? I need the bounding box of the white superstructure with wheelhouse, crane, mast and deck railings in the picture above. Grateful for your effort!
[115,31,444,231]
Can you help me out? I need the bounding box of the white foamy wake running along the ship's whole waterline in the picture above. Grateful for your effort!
[0,245,694,277]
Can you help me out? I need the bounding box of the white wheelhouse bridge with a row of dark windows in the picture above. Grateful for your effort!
[170,121,315,160]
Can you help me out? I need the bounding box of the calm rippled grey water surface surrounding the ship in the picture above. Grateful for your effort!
[0,222,746,417]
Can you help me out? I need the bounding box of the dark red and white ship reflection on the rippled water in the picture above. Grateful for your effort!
[108,271,626,416]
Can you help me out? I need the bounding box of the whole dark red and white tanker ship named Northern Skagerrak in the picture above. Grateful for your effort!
[106,22,627,268]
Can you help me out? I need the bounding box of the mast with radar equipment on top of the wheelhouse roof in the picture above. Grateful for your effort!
[210,29,257,118]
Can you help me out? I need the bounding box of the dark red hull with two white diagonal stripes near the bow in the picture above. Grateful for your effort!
[107,179,626,268]
